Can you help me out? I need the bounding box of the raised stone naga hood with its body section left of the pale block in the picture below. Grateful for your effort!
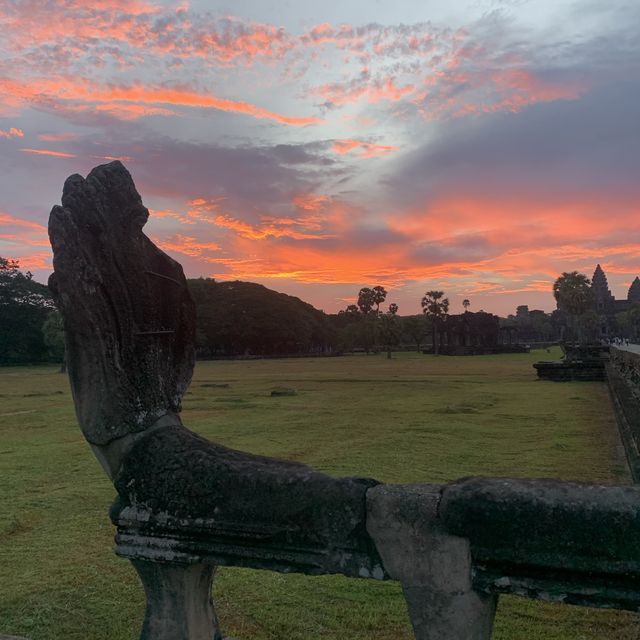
[49,161,384,640]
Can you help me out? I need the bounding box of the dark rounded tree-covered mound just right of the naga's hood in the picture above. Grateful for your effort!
[187,278,332,358]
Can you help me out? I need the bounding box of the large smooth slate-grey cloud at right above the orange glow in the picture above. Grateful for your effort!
[386,79,640,205]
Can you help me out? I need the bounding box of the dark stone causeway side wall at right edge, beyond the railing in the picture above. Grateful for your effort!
[606,347,640,483]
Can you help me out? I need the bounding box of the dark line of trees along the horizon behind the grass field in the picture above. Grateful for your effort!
[5,257,640,365]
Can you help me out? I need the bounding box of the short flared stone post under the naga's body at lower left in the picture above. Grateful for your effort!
[131,560,223,640]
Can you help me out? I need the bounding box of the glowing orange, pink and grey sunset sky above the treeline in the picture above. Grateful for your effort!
[0,0,640,315]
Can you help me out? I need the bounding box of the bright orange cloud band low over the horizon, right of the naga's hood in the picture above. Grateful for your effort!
[174,186,640,306]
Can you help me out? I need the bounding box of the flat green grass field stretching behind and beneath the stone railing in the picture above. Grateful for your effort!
[0,352,640,640]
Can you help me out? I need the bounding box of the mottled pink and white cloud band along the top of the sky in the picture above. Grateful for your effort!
[0,0,585,126]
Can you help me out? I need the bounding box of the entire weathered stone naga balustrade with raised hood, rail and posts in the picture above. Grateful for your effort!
[49,162,640,640]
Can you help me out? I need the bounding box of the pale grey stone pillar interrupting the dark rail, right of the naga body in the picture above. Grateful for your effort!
[367,485,497,640]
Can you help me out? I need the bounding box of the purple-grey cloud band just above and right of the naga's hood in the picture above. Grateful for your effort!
[56,137,346,221]
